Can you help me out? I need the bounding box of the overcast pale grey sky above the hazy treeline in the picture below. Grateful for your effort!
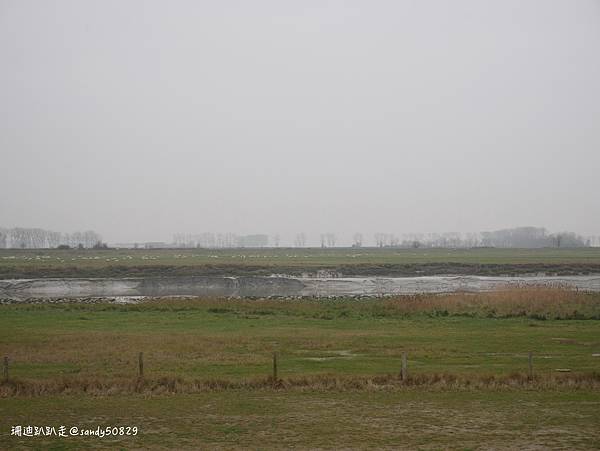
[0,0,600,244]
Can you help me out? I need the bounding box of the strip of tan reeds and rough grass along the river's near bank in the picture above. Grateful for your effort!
[2,287,600,322]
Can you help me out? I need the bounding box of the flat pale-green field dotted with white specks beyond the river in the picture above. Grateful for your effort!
[0,248,600,278]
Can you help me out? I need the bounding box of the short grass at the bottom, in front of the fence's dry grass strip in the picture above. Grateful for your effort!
[0,390,600,449]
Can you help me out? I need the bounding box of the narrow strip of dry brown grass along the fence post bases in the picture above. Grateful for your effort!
[0,372,600,398]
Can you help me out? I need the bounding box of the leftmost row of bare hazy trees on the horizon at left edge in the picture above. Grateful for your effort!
[0,227,106,249]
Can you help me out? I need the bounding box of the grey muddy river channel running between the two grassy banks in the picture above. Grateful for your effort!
[0,276,600,300]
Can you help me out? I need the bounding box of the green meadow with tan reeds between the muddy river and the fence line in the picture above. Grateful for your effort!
[0,289,600,395]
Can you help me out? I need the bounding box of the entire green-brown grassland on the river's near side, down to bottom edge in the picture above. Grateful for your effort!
[0,289,600,449]
